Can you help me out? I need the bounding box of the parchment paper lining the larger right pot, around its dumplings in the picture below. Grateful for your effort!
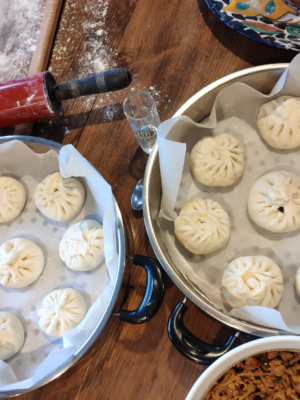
[158,55,300,333]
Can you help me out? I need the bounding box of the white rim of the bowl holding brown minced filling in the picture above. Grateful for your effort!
[186,336,300,400]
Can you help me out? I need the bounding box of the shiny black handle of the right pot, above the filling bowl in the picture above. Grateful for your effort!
[168,298,240,365]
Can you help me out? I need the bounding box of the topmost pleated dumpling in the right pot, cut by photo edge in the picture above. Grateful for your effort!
[257,96,300,149]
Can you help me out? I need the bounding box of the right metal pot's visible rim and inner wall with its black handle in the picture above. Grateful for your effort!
[143,64,288,365]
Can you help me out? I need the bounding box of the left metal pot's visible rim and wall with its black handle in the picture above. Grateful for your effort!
[0,136,165,398]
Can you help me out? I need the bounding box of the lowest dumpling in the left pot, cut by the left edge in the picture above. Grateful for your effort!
[0,311,24,361]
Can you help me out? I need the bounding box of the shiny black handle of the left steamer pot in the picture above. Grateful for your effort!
[119,255,165,325]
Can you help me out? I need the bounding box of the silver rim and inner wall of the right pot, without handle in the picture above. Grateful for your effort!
[143,64,290,337]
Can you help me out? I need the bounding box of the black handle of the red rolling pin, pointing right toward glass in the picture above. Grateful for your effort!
[53,68,132,101]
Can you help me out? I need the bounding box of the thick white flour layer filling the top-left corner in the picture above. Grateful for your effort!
[0,0,46,82]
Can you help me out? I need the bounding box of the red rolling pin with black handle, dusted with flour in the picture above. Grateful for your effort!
[0,68,131,128]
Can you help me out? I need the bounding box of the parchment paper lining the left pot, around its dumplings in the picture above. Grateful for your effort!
[0,141,118,391]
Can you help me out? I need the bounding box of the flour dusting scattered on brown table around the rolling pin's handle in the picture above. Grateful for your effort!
[39,0,172,134]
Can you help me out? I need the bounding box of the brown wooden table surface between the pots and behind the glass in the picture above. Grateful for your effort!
[8,0,295,400]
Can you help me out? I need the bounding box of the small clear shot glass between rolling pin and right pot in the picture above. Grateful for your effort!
[123,92,160,154]
